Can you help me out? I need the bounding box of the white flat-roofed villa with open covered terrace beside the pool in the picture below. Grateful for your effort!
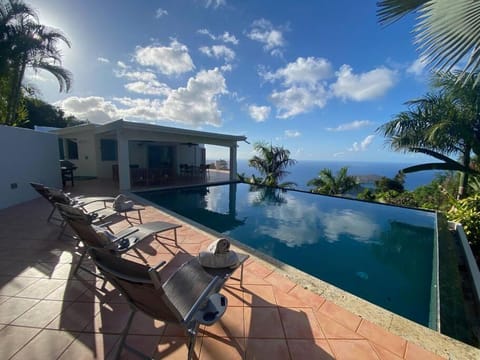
[54,120,246,190]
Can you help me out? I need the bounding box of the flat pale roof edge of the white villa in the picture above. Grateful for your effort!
[55,119,247,146]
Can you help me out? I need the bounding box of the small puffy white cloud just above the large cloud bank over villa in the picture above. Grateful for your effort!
[135,40,195,75]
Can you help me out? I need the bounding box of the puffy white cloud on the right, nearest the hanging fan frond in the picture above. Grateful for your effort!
[331,65,396,101]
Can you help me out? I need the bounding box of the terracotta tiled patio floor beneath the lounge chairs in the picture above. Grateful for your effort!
[0,181,450,360]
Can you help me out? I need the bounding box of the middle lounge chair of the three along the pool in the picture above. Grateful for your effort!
[57,204,181,275]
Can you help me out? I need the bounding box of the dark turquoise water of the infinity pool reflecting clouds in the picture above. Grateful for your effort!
[138,184,436,326]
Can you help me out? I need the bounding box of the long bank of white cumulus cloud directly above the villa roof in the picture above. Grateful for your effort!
[56,68,227,127]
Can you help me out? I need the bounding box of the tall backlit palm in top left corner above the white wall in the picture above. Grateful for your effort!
[0,0,72,125]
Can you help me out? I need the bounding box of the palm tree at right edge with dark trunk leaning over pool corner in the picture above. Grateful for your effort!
[377,72,480,198]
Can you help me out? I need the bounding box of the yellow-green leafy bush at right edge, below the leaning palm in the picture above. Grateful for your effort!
[447,194,480,257]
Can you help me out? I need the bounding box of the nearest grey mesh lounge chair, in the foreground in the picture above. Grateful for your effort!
[89,249,227,359]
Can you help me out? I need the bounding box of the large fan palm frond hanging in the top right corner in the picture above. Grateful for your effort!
[377,0,480,82]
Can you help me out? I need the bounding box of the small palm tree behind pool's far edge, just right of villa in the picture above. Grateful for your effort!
[248,142,297,187]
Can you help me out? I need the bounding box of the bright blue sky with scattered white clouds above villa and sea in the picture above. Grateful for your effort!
[27,0,428,163]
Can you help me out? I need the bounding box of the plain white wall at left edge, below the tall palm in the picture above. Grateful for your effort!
[0,125,62,209]
